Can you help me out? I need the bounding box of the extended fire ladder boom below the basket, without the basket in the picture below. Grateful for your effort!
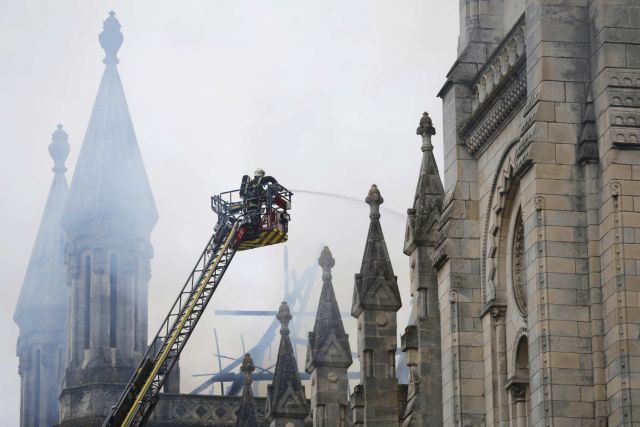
[102,221,239,427]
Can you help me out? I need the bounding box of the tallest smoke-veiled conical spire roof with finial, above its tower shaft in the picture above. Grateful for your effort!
[63,12,158,233]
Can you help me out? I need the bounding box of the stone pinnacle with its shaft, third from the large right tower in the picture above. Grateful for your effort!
[306,246,353,427]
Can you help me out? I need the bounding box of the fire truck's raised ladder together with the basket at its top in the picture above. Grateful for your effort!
[102,182,292,427]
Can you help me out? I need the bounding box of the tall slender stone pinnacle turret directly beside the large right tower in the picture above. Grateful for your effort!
[402,113,444,426]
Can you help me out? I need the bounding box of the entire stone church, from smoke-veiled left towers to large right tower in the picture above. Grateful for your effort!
[15,0,640,427]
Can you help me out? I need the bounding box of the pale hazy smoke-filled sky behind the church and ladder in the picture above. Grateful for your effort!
[0,0,458,425]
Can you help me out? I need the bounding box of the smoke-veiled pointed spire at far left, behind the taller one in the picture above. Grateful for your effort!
[14,124,69,326]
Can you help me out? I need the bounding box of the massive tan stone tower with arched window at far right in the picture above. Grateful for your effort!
[433,0,640,426]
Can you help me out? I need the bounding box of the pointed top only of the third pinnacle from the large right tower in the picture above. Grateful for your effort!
[305,246,353,373]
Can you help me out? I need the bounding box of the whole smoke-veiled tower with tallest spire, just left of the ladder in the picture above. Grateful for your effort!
[60,12,158,426]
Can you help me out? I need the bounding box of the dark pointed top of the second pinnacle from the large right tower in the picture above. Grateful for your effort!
[351,184,402,317]
